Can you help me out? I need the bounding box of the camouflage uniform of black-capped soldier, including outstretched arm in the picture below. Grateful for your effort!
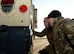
[33,18,73,54]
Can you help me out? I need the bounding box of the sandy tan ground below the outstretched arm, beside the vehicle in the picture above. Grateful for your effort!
[33,37,49,54]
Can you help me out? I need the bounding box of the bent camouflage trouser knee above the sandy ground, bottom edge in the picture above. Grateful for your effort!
[38,45,55,54]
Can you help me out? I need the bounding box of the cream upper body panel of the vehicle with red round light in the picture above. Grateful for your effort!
[0,0,32,26]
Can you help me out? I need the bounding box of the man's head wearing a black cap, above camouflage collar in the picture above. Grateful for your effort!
[48,10,61,27]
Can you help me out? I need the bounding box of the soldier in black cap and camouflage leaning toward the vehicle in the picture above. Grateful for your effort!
[33,10,73,54]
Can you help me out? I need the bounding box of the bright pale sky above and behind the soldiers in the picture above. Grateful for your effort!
[32,0,74,32]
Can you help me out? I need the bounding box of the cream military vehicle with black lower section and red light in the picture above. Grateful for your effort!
[0,0,36,54]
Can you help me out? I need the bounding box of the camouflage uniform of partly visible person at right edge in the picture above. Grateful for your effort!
[66,19,74,52]
